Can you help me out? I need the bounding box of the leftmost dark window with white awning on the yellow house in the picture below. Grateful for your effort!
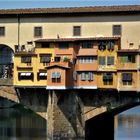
[18,72,33,80]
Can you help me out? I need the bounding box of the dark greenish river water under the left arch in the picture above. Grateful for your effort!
[0,106,46,140]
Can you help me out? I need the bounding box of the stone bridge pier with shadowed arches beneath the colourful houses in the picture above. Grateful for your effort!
[0,88,140,140]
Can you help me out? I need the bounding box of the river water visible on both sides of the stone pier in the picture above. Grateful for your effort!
[0,100,140,140]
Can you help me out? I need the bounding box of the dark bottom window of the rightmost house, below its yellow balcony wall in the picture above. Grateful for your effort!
[122,73,132,85]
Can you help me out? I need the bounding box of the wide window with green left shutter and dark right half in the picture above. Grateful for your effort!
[120,55,136,63]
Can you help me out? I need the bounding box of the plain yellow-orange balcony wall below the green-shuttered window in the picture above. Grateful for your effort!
[117,63,137,70]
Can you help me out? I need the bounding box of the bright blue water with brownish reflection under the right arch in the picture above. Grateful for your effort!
[115,106,140,140]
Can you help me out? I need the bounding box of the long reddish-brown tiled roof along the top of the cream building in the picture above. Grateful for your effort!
[0,5,140,15]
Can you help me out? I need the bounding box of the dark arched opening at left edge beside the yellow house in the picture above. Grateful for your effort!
[0,44,14,81]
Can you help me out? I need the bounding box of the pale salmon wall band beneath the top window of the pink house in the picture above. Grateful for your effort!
[77,48,97,56]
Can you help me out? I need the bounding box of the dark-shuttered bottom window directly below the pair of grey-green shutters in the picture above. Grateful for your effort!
[103,73,113,85]
